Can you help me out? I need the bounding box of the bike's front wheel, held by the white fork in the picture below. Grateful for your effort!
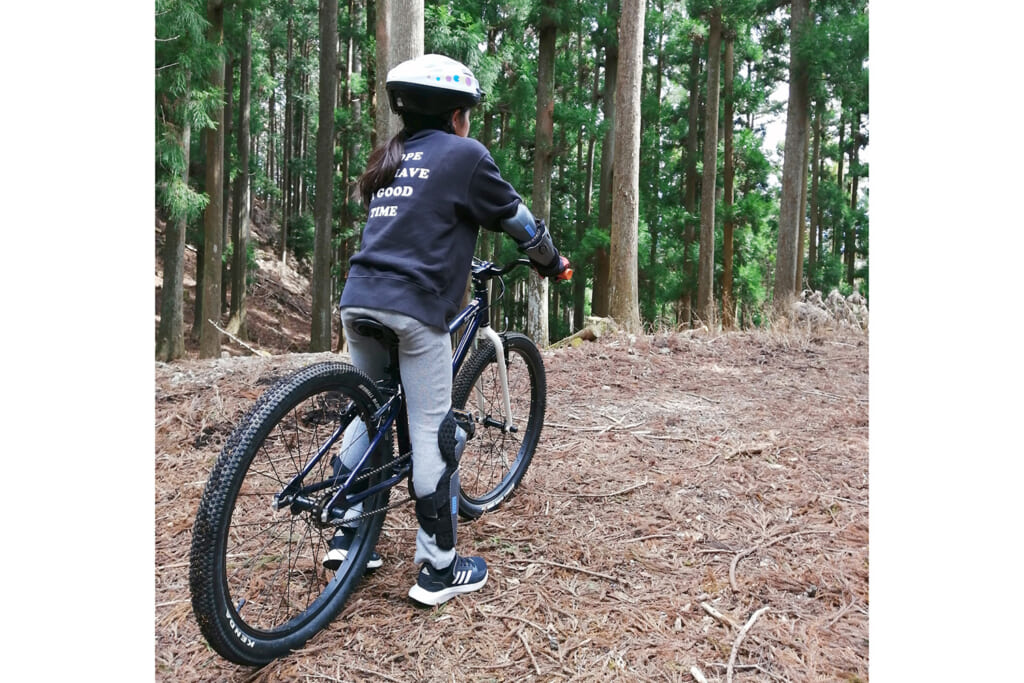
[452,333,547,519]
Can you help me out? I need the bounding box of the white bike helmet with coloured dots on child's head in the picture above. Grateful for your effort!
[386,54,484,115]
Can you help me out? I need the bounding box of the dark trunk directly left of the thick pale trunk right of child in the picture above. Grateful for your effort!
[591,0,620,317]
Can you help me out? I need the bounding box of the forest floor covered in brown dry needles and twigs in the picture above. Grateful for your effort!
[155,215,868,683]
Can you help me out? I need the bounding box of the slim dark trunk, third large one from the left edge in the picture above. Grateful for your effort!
[227,9,253,339]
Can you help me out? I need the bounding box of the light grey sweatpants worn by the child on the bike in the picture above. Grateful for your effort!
[341,307,456,569]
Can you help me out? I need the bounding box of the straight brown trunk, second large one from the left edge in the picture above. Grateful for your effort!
[199,0,224,358]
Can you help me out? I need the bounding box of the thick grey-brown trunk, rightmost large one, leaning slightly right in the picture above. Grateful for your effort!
[773,0,810,316]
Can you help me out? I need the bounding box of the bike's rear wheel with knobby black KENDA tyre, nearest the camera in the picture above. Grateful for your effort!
[188,362,391,665]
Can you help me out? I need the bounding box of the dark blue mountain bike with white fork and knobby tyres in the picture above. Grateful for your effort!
[188,259,571,666]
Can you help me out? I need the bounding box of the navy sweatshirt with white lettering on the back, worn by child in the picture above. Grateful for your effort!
[340,130,522,329]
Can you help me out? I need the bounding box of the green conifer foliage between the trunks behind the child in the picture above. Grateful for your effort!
[154,0,869,337]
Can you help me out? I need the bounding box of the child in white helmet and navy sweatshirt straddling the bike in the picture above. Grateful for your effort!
[324,54,568,605]
